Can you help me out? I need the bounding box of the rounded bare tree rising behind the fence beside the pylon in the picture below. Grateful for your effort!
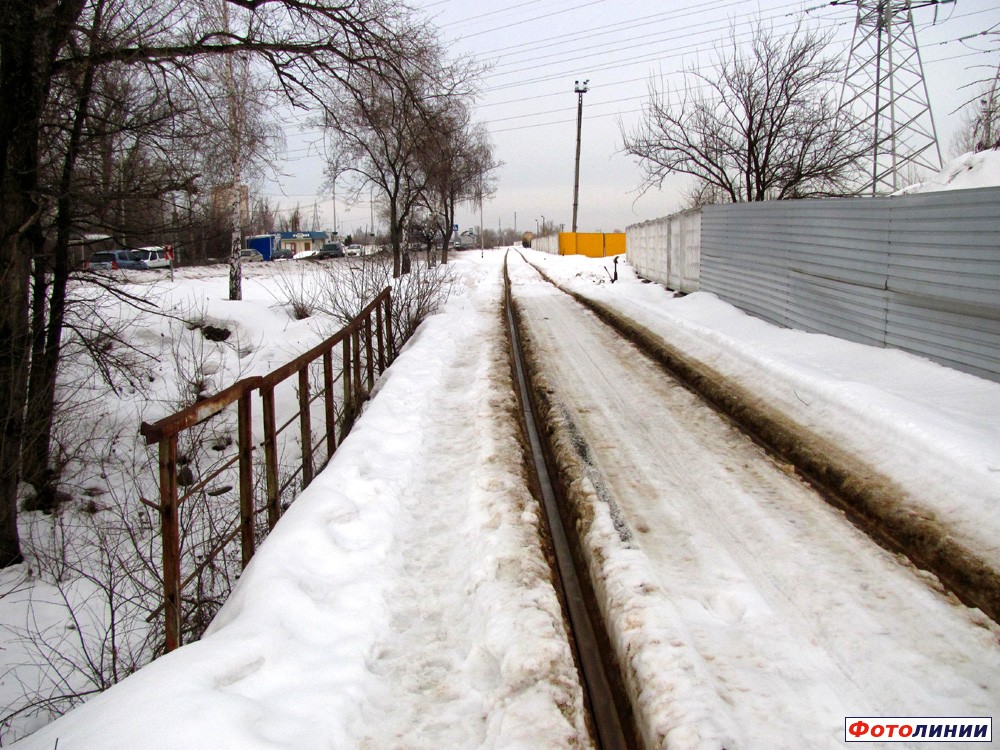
[622,25,871,203]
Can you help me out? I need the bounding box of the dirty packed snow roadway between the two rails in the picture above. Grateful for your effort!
[511,254,1000,748]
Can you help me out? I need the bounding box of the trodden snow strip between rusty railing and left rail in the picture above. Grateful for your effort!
[9,254,593,750]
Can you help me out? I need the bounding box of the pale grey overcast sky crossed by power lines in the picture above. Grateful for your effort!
[263,0,1000,238]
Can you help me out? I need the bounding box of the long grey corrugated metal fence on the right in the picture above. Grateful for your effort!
[700,188,1000,380]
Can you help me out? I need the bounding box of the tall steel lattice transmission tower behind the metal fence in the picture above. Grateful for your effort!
[831,0,955,195]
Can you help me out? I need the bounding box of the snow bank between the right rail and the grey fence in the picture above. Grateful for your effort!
[528,253,1000,569]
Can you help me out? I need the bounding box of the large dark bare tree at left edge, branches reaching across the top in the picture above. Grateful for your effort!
[0,0,423,565]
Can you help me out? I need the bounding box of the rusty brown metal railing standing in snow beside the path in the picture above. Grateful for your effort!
[140,288,395,651]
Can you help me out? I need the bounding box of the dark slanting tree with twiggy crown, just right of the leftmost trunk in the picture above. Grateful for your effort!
[21,11,205,510]
